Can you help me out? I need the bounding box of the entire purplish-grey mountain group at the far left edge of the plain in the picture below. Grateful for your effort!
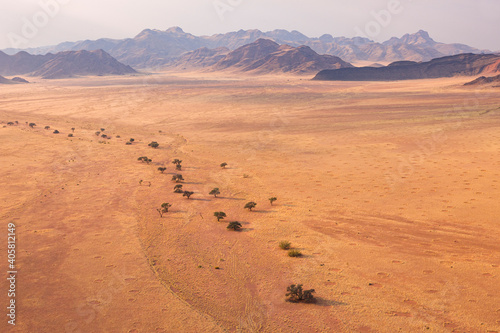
[0,50,136,79]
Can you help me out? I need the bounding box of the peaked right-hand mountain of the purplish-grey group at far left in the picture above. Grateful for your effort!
[31,50,136,79]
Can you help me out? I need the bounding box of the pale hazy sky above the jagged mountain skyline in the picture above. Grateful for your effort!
[0,0,500,51]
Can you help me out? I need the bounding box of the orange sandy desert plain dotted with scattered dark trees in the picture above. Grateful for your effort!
[0,73,500,332]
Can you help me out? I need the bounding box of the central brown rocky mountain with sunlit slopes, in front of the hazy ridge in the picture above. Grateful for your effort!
[172,38,353,74]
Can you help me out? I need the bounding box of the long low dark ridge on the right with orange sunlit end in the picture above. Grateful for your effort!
[314,53,500,81]
